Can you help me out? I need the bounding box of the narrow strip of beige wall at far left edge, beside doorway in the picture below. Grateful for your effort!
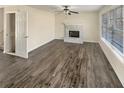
[0,8,4,48]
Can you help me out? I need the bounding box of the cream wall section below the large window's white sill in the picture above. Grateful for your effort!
[99,40,124,87]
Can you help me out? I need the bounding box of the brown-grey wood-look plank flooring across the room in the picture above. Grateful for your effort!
[0,40,122,88]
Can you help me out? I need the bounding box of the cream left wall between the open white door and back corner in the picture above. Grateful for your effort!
[5,6,55,52]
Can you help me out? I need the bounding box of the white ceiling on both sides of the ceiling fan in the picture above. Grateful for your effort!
[30,5,103,12]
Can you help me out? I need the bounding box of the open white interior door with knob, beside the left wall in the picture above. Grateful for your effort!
[16,12,28,58]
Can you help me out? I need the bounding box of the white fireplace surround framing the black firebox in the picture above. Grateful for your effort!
[64,24,83,44]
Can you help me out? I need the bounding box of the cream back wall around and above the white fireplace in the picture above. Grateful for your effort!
[55,12,99,42]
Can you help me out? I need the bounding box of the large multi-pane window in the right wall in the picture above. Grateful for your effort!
[102,6,124,53]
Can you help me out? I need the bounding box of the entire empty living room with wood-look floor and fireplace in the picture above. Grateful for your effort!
[0,5,124,88]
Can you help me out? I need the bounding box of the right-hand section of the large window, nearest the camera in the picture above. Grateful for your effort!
[112,6,123,53]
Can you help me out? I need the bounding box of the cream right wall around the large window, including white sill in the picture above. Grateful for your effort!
[99,6,124,86]
